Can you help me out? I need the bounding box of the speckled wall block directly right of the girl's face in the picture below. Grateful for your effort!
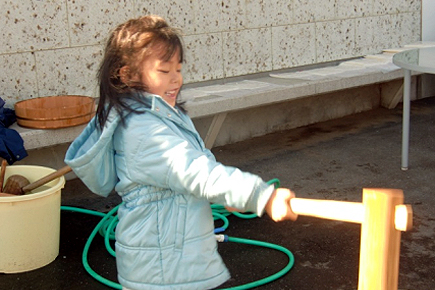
[183,33,224,83]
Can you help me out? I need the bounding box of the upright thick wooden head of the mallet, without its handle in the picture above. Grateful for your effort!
[358,188,404,290]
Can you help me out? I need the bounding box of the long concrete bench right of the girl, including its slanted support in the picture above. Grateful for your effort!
[181,53,418,148]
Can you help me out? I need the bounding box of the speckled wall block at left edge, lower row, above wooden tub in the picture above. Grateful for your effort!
[0,52,38,108]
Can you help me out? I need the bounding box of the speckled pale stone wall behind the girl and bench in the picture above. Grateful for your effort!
[0,0,421,107]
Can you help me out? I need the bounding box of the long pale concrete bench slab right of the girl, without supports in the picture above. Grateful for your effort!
[181,62,403,118]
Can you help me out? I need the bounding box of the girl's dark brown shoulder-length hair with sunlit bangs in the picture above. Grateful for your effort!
[96,15,183,129]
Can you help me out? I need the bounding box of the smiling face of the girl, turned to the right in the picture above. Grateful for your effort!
[139,50,183,107]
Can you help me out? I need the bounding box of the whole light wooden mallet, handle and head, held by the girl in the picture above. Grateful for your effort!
[290,188,412,290]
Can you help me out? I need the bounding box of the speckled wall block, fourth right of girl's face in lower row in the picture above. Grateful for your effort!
[316,19,355,62]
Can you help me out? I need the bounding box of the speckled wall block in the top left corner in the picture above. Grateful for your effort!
[0,0,69,54]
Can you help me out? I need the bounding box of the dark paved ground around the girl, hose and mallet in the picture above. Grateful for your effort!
[0,98,435,290]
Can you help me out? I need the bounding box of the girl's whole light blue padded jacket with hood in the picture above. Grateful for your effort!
[65,94,273,290]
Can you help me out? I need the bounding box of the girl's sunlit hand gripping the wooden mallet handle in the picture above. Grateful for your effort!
[266,188,298,222]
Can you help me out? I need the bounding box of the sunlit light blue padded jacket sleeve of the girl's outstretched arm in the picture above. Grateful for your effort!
[125,113,273,216]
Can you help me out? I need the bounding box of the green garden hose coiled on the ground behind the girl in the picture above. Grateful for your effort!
[61,179,294,290]
